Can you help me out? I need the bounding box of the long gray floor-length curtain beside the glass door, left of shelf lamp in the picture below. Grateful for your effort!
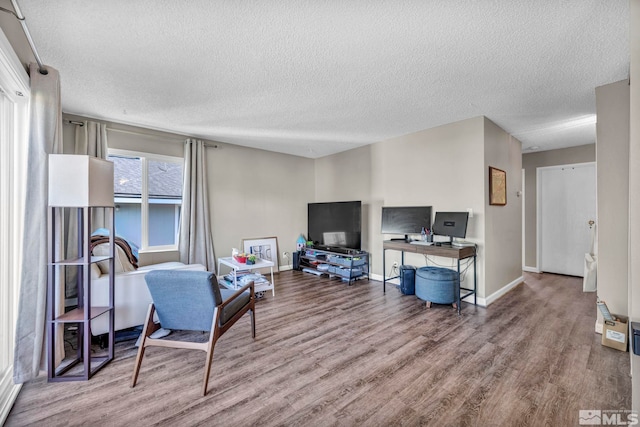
[13,64,62,384]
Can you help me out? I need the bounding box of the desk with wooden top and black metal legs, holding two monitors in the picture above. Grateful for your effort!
[382,240,478,314]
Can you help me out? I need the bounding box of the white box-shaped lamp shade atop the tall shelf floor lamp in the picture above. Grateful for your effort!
[49,154,114,207]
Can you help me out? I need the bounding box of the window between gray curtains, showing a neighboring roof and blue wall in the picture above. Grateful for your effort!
[107,150,182,251]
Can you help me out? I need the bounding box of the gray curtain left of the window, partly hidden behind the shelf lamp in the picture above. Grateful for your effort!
[64,121,107,298]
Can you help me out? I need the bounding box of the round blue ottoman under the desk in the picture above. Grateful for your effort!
[416,267,460,307]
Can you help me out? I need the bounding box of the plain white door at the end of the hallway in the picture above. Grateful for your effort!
[537,163,596,276]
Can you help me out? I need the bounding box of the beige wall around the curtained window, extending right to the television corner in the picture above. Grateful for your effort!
[63,115,315,266]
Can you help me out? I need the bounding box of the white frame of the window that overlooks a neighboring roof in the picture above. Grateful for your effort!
[108,148,184,253]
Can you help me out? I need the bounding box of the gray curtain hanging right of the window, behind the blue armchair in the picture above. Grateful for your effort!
[179,139,215,271]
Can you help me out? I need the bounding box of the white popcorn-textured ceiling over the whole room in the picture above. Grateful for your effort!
[19,0,629,158]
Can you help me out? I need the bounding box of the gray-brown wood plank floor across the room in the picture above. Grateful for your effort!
[6,271,631,426]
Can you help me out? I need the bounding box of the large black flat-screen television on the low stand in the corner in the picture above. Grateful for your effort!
[307,201,362,250]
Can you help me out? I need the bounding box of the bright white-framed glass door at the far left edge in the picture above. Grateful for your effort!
[0,30,30,425]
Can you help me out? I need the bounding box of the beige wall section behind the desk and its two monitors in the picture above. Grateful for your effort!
[372,117,485,297]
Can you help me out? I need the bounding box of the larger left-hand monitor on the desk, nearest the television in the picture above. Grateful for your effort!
[381,206,431,241]
